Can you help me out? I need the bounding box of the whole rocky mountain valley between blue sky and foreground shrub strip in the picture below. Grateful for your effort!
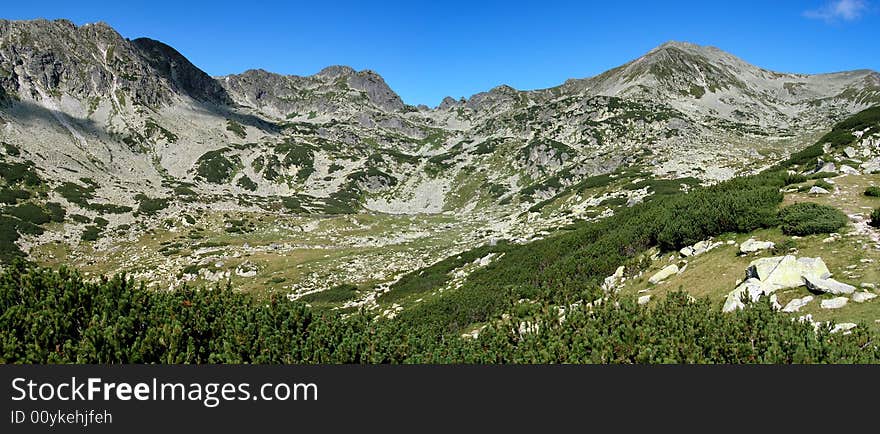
[0,20,880,363]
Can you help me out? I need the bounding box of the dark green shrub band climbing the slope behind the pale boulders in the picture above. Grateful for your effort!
[398,172,785,333]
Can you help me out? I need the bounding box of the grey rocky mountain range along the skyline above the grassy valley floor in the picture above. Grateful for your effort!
[0,20,880,231]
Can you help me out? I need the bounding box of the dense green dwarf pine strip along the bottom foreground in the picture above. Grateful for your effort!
[0,263,880,363]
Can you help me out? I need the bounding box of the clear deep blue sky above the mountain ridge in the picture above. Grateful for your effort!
[0,0,880,106]
